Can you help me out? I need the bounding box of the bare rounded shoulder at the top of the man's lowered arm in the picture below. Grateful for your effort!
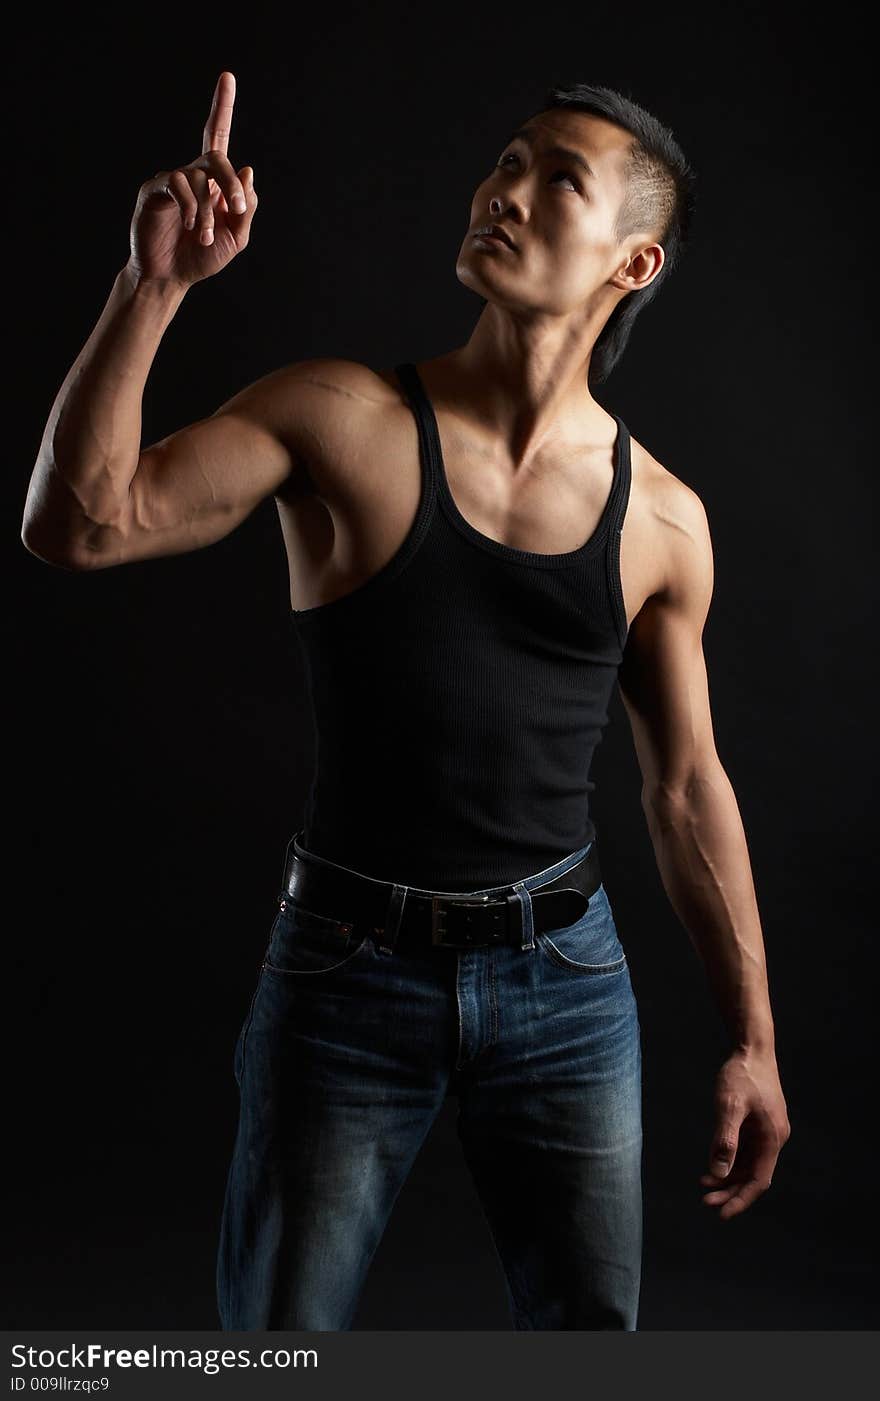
[631,439,713,615]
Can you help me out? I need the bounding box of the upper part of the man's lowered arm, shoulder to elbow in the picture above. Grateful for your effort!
[618,489,717,792]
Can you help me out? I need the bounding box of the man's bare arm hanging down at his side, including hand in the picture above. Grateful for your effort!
[619,474,790,1220]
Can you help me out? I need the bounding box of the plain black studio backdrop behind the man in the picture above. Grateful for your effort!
[3,4,877,1330]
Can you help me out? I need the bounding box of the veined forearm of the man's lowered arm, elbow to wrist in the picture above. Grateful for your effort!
[642,762,775,1052]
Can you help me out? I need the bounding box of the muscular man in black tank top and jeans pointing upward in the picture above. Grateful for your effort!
[22,73,789,1330]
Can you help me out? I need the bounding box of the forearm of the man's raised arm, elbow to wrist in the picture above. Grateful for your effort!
[21,265,186,560]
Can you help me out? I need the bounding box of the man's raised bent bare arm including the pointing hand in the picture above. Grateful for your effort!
[21,73,276,569]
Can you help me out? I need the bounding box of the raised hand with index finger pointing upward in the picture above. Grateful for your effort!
[126,73,256,286]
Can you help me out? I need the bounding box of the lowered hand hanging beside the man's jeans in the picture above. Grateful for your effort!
[701,1051,792,1220]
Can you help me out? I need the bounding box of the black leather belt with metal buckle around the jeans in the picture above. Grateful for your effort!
[280,834,601,948]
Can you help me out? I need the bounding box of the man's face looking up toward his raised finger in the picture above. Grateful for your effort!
[455,109,638,315]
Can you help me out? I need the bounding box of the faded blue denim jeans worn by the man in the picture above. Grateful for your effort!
[217,834,643,1331]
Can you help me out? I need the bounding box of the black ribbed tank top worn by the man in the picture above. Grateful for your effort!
[291,363,631,891]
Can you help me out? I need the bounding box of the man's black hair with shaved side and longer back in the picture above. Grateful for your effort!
[515,83,696,384]
